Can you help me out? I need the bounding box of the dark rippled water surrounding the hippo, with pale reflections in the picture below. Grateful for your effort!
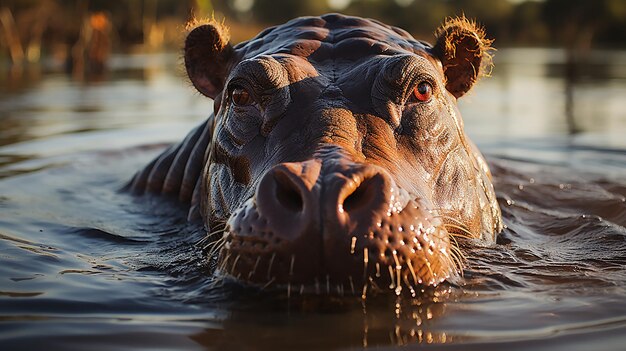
[0,50,626,350]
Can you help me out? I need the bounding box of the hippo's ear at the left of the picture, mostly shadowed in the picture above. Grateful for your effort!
[185,20,234,99]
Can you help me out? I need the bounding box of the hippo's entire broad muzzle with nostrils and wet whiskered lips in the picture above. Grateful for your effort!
[220,153,454,294]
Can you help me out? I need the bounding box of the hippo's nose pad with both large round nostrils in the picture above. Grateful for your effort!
[256,161,392,245]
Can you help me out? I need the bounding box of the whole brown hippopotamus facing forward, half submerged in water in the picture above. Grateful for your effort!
[129,14,502,296]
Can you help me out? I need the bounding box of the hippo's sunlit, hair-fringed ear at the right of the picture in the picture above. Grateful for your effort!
[433,16,493,98]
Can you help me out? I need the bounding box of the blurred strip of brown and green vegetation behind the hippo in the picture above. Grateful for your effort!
[0,0,626,66]
